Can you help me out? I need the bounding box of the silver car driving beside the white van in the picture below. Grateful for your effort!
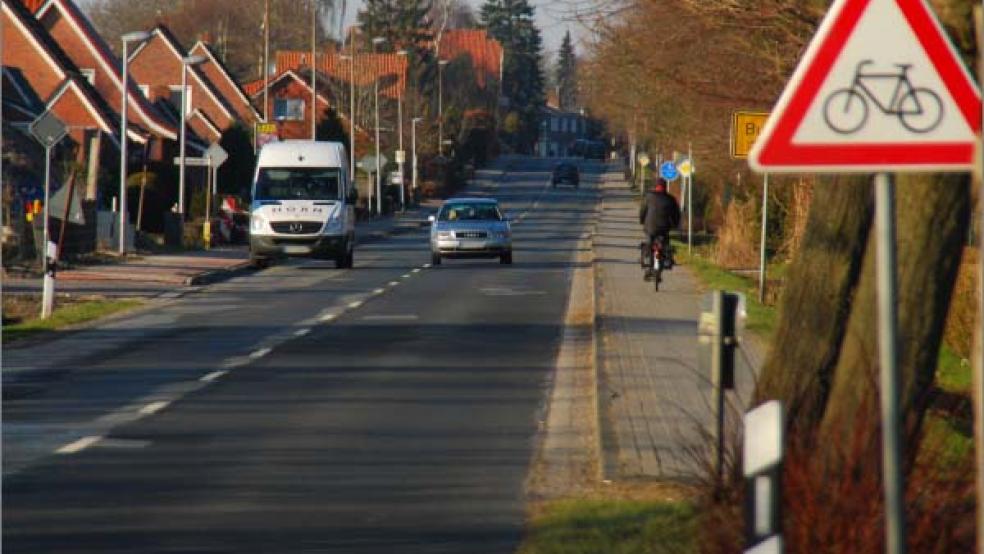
[430,198,512,265]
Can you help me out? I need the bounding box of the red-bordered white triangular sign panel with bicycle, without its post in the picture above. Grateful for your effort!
[749,0,981,173]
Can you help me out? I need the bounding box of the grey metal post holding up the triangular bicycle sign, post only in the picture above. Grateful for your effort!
[875,173,906,554]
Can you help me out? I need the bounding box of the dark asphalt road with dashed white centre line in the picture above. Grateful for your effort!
[3,155,600,553]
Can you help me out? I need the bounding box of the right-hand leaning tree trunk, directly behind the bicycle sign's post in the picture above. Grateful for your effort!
[820,175,970,467]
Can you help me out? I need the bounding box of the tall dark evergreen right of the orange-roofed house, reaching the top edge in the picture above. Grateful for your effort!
[481,0,544,152]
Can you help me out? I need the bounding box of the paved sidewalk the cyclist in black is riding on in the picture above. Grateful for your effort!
[594,174,761,481]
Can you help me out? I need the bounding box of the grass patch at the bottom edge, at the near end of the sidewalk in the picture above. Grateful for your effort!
[519,498,697,554]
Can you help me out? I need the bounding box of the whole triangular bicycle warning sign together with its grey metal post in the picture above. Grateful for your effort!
[749,0,982,554]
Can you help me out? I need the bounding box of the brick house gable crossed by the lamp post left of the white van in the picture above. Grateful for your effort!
[130,25,238,142]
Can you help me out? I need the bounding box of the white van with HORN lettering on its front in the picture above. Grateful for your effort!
[249,140,356,267]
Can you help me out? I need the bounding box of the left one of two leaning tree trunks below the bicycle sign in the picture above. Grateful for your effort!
[756,177,874,432]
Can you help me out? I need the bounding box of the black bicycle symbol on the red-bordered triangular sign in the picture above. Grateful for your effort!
[823,60,943,135]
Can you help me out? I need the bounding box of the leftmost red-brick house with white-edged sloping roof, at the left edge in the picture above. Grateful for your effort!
[0,1,120,199]
